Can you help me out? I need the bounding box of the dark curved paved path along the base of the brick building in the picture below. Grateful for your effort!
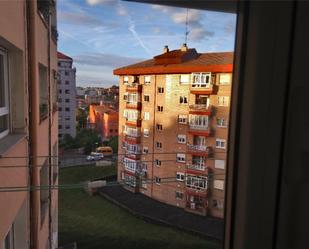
[99,186,223,241]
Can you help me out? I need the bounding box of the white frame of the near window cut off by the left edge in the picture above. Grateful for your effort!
[0,47,10,139]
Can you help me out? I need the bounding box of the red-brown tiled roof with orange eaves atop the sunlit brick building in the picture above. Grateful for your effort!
[114,49,234,75]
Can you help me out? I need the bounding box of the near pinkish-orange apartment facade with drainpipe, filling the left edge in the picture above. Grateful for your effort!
[0,0,58,249]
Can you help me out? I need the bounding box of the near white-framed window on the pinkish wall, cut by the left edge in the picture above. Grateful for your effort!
[0,48,9,138]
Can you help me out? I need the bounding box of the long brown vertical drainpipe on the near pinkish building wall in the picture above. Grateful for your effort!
[26,0,40,249]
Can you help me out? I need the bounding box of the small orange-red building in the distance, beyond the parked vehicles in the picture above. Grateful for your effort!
[88,103,119,140]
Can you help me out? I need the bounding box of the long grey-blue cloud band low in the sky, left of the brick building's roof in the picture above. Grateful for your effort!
[73,53,143,68]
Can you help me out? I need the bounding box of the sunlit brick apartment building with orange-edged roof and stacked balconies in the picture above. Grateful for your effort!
[114,45,233,218]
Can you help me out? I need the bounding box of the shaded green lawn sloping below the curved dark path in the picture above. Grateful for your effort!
[59,166,219,249]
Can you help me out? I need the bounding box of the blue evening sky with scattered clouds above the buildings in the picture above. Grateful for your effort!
[57,0,236,87]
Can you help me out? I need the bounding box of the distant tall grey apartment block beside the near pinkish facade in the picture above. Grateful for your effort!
[57,52,76,138]
